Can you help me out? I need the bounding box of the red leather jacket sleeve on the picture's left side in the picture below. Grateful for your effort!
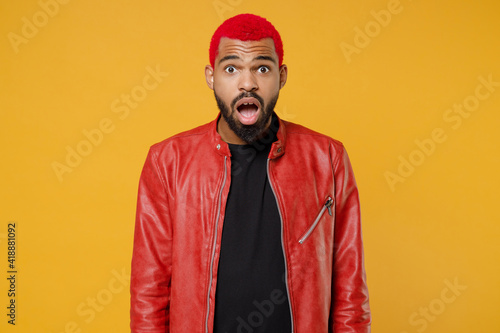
[130,150,172,333]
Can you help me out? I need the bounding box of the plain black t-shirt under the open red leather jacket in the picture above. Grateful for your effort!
[214,117,291,333]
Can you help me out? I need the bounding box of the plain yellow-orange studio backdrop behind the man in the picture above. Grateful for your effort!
[0,0,500,333]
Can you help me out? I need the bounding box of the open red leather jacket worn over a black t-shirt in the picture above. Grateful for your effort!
[130,113,371,333]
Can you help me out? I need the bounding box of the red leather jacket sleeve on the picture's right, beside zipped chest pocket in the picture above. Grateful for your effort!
[330,146,371,333]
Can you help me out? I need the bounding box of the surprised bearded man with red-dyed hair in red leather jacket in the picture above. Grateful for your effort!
[131,14,371,333]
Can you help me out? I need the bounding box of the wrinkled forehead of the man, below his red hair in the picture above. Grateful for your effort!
[217,37,278,62]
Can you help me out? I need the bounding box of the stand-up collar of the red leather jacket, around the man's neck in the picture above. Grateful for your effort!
[210,112,286,159]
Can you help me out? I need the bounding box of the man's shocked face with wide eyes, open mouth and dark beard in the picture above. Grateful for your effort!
[205,38,287,144]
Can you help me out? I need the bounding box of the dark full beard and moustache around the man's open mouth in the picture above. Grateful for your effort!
[214,90,279,144]
